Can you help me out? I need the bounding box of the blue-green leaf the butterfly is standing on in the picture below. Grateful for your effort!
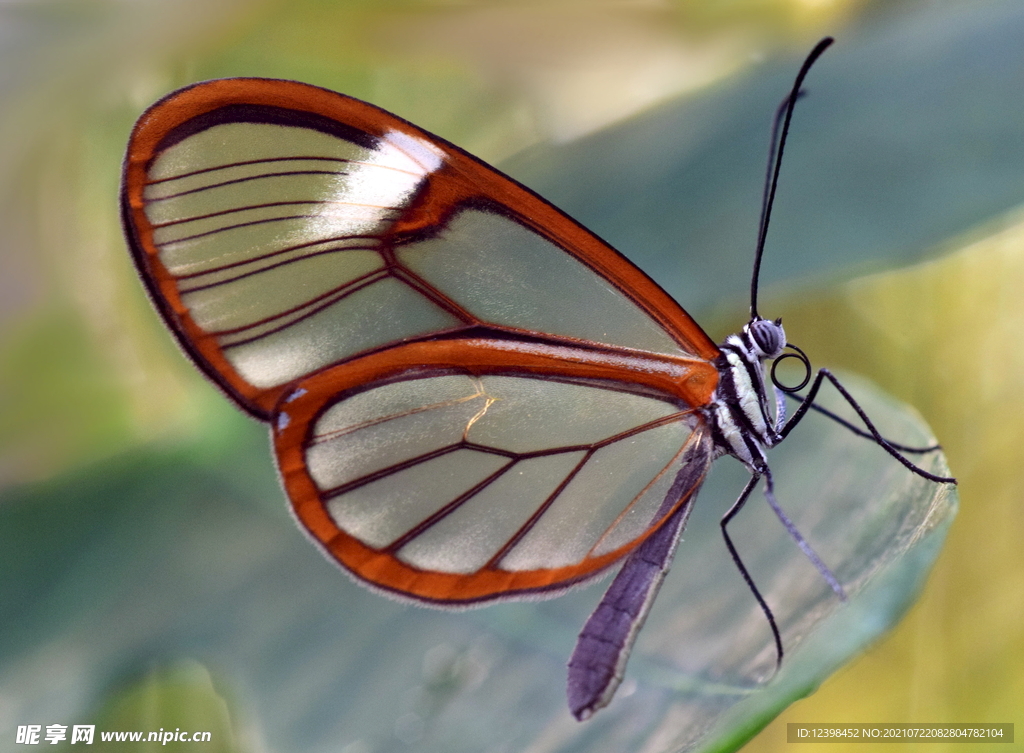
[0,380,956,753]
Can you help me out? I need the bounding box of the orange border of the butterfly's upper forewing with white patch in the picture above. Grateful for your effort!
[121,78,719,420]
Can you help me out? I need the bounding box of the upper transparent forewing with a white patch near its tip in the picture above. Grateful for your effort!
[122,79,718,418]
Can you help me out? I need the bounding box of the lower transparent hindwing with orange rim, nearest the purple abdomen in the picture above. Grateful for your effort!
[274,344,710,604]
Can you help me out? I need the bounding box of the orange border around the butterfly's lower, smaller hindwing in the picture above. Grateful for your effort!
[272,339,718,608]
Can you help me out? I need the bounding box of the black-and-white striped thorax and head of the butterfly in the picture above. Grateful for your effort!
[707,319,785,470]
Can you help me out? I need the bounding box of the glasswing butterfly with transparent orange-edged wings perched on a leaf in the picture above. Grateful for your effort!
[121,40,951,719]
